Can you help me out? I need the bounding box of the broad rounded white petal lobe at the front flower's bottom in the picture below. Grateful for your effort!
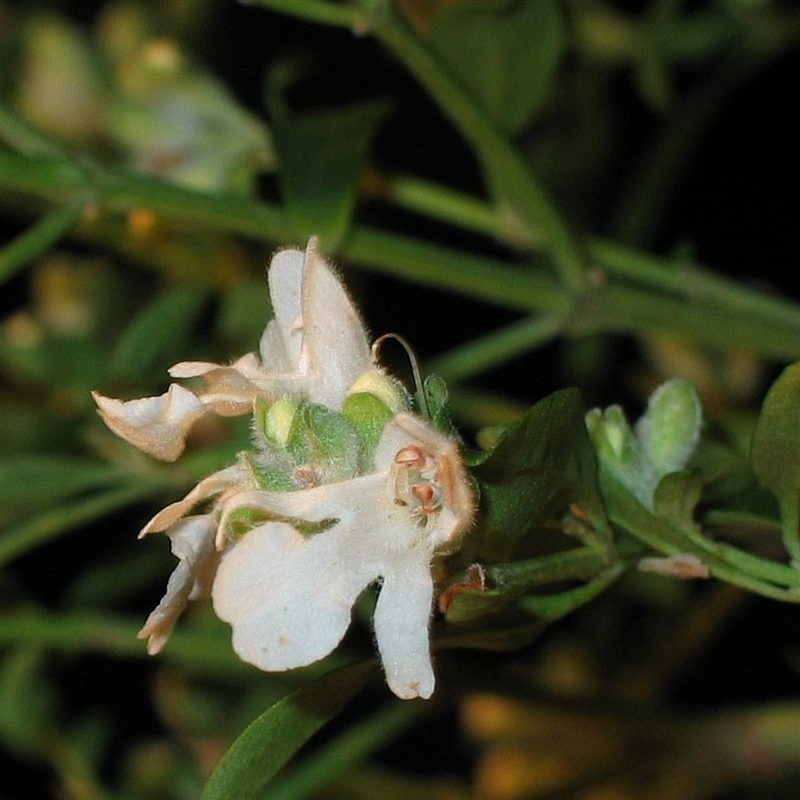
[212,522,376,671]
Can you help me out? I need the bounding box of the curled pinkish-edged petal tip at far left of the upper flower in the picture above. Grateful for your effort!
[92,383,206,461]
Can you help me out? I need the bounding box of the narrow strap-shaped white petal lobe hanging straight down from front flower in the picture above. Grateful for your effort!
[374,548,435,700]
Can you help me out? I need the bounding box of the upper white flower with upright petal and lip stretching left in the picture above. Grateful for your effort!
[93,239,375,461]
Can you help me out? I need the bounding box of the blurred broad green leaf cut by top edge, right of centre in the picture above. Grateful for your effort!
[429,0,565,135]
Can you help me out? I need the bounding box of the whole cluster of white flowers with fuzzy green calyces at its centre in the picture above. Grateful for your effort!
[95,240,473,698]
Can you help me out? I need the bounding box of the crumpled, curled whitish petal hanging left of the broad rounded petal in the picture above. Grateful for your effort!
[137,514,217,655]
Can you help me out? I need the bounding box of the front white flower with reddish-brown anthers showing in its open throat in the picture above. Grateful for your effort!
[212,414,472,699]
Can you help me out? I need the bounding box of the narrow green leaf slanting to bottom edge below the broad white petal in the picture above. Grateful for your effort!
[201,661,375,800]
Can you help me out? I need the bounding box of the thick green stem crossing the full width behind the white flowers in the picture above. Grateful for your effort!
[0,150,800,358]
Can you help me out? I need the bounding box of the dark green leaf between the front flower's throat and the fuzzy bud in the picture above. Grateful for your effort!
[473,389,605,561]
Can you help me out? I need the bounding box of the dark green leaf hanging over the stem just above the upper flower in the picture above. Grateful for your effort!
[274,102,390,251]
